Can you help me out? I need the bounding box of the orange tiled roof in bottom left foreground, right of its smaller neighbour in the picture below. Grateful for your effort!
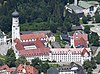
[17,64,38,74]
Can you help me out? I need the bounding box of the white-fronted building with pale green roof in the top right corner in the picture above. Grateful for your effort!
[78,1,99,16]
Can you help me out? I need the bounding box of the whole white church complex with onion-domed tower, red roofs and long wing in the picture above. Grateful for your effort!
[12,10,92,64]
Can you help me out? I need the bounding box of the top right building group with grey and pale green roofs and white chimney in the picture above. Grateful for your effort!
[65,0,99,17]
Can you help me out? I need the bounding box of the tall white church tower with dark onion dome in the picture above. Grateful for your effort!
[12,10,20,44]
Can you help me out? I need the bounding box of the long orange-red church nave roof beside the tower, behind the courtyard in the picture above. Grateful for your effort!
[20,33,46,40]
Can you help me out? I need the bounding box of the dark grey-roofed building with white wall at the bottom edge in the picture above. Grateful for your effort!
[47,62,85,74]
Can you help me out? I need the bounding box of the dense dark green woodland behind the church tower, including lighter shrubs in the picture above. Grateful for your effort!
[0,0,99,32]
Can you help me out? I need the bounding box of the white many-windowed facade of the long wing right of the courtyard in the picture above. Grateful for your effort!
[50,48,91,64]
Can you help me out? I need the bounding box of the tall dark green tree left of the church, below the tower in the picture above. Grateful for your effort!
[6,48,16,67]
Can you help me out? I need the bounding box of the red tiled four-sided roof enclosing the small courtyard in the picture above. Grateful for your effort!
[15,39,50,56]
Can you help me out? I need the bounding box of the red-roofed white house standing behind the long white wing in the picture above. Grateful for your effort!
[70,31,88,48]
